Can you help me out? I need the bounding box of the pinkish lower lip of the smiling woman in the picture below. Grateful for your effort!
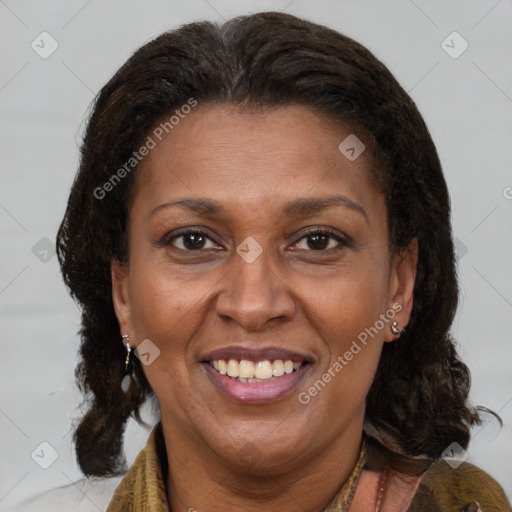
[203,363,311,404]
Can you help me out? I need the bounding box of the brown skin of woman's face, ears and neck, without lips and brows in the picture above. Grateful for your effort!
[112,104,417,512]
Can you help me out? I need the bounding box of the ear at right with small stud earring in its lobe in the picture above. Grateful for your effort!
[386,238,419,341]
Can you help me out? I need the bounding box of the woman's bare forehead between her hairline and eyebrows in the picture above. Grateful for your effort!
[130,104,378,222]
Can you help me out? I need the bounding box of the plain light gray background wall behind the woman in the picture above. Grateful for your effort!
[0,0,512,509]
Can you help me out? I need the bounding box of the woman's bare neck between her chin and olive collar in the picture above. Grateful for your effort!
[162,417,362,512]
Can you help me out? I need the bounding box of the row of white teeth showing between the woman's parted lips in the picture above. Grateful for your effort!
[205,359,309,383]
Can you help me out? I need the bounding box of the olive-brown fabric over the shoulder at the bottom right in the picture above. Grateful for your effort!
[409,460,512,512]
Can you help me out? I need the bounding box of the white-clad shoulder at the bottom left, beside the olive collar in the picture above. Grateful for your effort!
[16,476,123,512]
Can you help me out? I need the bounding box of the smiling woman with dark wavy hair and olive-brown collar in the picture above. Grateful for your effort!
[33,13,510,512]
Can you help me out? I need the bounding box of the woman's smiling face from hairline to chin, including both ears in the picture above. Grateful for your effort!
[112,105,416,468]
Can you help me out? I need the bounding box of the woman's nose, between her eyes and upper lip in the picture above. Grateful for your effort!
[216,250,295,331]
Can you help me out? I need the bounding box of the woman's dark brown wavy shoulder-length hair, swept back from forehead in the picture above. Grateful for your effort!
[57,12,486,476]
